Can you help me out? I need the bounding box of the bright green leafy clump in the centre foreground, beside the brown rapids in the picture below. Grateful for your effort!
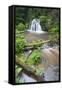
[27,50,41,65]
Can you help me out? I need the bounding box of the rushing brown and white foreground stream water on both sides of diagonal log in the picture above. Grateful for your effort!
[20,46,59,82]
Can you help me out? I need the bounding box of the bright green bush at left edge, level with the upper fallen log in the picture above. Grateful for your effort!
[16,37,25,53]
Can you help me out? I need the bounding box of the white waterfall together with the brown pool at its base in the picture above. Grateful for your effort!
[25,19,48,42]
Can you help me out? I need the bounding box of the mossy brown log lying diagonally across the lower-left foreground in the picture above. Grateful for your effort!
[16,58,43,82]
